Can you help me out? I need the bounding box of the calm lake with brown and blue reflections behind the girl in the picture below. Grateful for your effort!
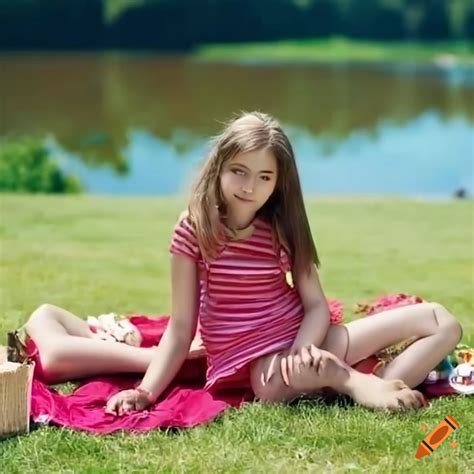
[0,53,474,198]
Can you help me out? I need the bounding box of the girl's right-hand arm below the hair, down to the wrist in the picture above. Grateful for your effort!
[291,265,329,350]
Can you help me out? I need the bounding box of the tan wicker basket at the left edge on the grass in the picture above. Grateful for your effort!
[0,362,34,438]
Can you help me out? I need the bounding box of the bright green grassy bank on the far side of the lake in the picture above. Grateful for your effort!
[195,37,474,64]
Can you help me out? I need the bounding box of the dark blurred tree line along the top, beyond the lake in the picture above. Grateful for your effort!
[0,0,474,51]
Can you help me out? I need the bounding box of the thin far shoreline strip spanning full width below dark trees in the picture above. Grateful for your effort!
[0,37,474,69]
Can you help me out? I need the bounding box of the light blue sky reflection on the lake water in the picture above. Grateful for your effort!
[50,112,474,197]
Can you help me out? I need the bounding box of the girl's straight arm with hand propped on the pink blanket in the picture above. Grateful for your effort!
[106,254,199,415]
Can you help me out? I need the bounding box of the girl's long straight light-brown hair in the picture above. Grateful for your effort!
[188,112,320,273]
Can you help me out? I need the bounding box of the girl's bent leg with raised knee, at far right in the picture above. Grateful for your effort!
[321,303,462,387]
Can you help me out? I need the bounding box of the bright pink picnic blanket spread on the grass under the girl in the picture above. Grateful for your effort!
[31,295,455,434]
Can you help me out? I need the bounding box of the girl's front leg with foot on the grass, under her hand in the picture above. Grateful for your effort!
[250,351,424,411]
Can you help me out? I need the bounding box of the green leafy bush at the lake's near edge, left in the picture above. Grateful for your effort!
[0,137,82,193]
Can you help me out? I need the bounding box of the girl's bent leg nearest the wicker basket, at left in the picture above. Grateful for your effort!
[26,304,202,382]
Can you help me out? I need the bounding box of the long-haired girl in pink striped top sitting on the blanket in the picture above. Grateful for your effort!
[23,112,462,414]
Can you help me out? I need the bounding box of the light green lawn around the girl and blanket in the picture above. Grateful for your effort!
[0,195,474,473]
